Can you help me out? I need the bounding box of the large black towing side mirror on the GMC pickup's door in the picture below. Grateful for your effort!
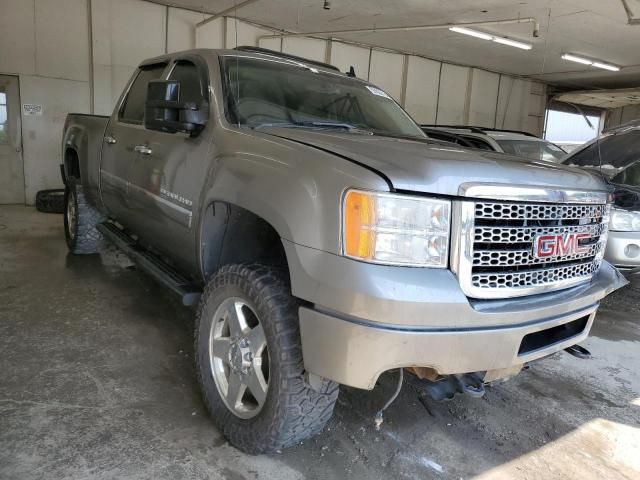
[144,80,209,137]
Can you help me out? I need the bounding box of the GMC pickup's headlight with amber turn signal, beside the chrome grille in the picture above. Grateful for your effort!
[342,190,451,268]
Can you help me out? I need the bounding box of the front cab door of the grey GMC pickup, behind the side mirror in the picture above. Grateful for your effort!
[129,55,213,268]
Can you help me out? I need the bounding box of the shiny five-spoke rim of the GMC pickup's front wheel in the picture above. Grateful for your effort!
[209,297,269,419]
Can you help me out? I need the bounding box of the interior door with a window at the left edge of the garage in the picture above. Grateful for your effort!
[0,75,25,204]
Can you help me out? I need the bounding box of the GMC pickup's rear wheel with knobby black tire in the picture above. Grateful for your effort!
[64,178,105,255]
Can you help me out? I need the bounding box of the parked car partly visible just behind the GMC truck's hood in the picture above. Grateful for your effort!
[421,125,567,163]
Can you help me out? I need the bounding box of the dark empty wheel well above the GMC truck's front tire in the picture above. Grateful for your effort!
[200,202,289,281]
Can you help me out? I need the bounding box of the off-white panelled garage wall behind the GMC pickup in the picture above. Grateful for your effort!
[0,0,546,204]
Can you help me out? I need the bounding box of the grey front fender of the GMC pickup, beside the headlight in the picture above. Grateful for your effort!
[200,127,389,253]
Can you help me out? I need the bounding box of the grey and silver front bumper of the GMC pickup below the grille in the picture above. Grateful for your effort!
[283,241,627,389]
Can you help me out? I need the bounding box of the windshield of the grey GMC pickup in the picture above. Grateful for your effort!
[223,56,426,138]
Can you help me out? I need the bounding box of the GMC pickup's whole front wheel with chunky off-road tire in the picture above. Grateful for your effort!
[195,265,338,453]
